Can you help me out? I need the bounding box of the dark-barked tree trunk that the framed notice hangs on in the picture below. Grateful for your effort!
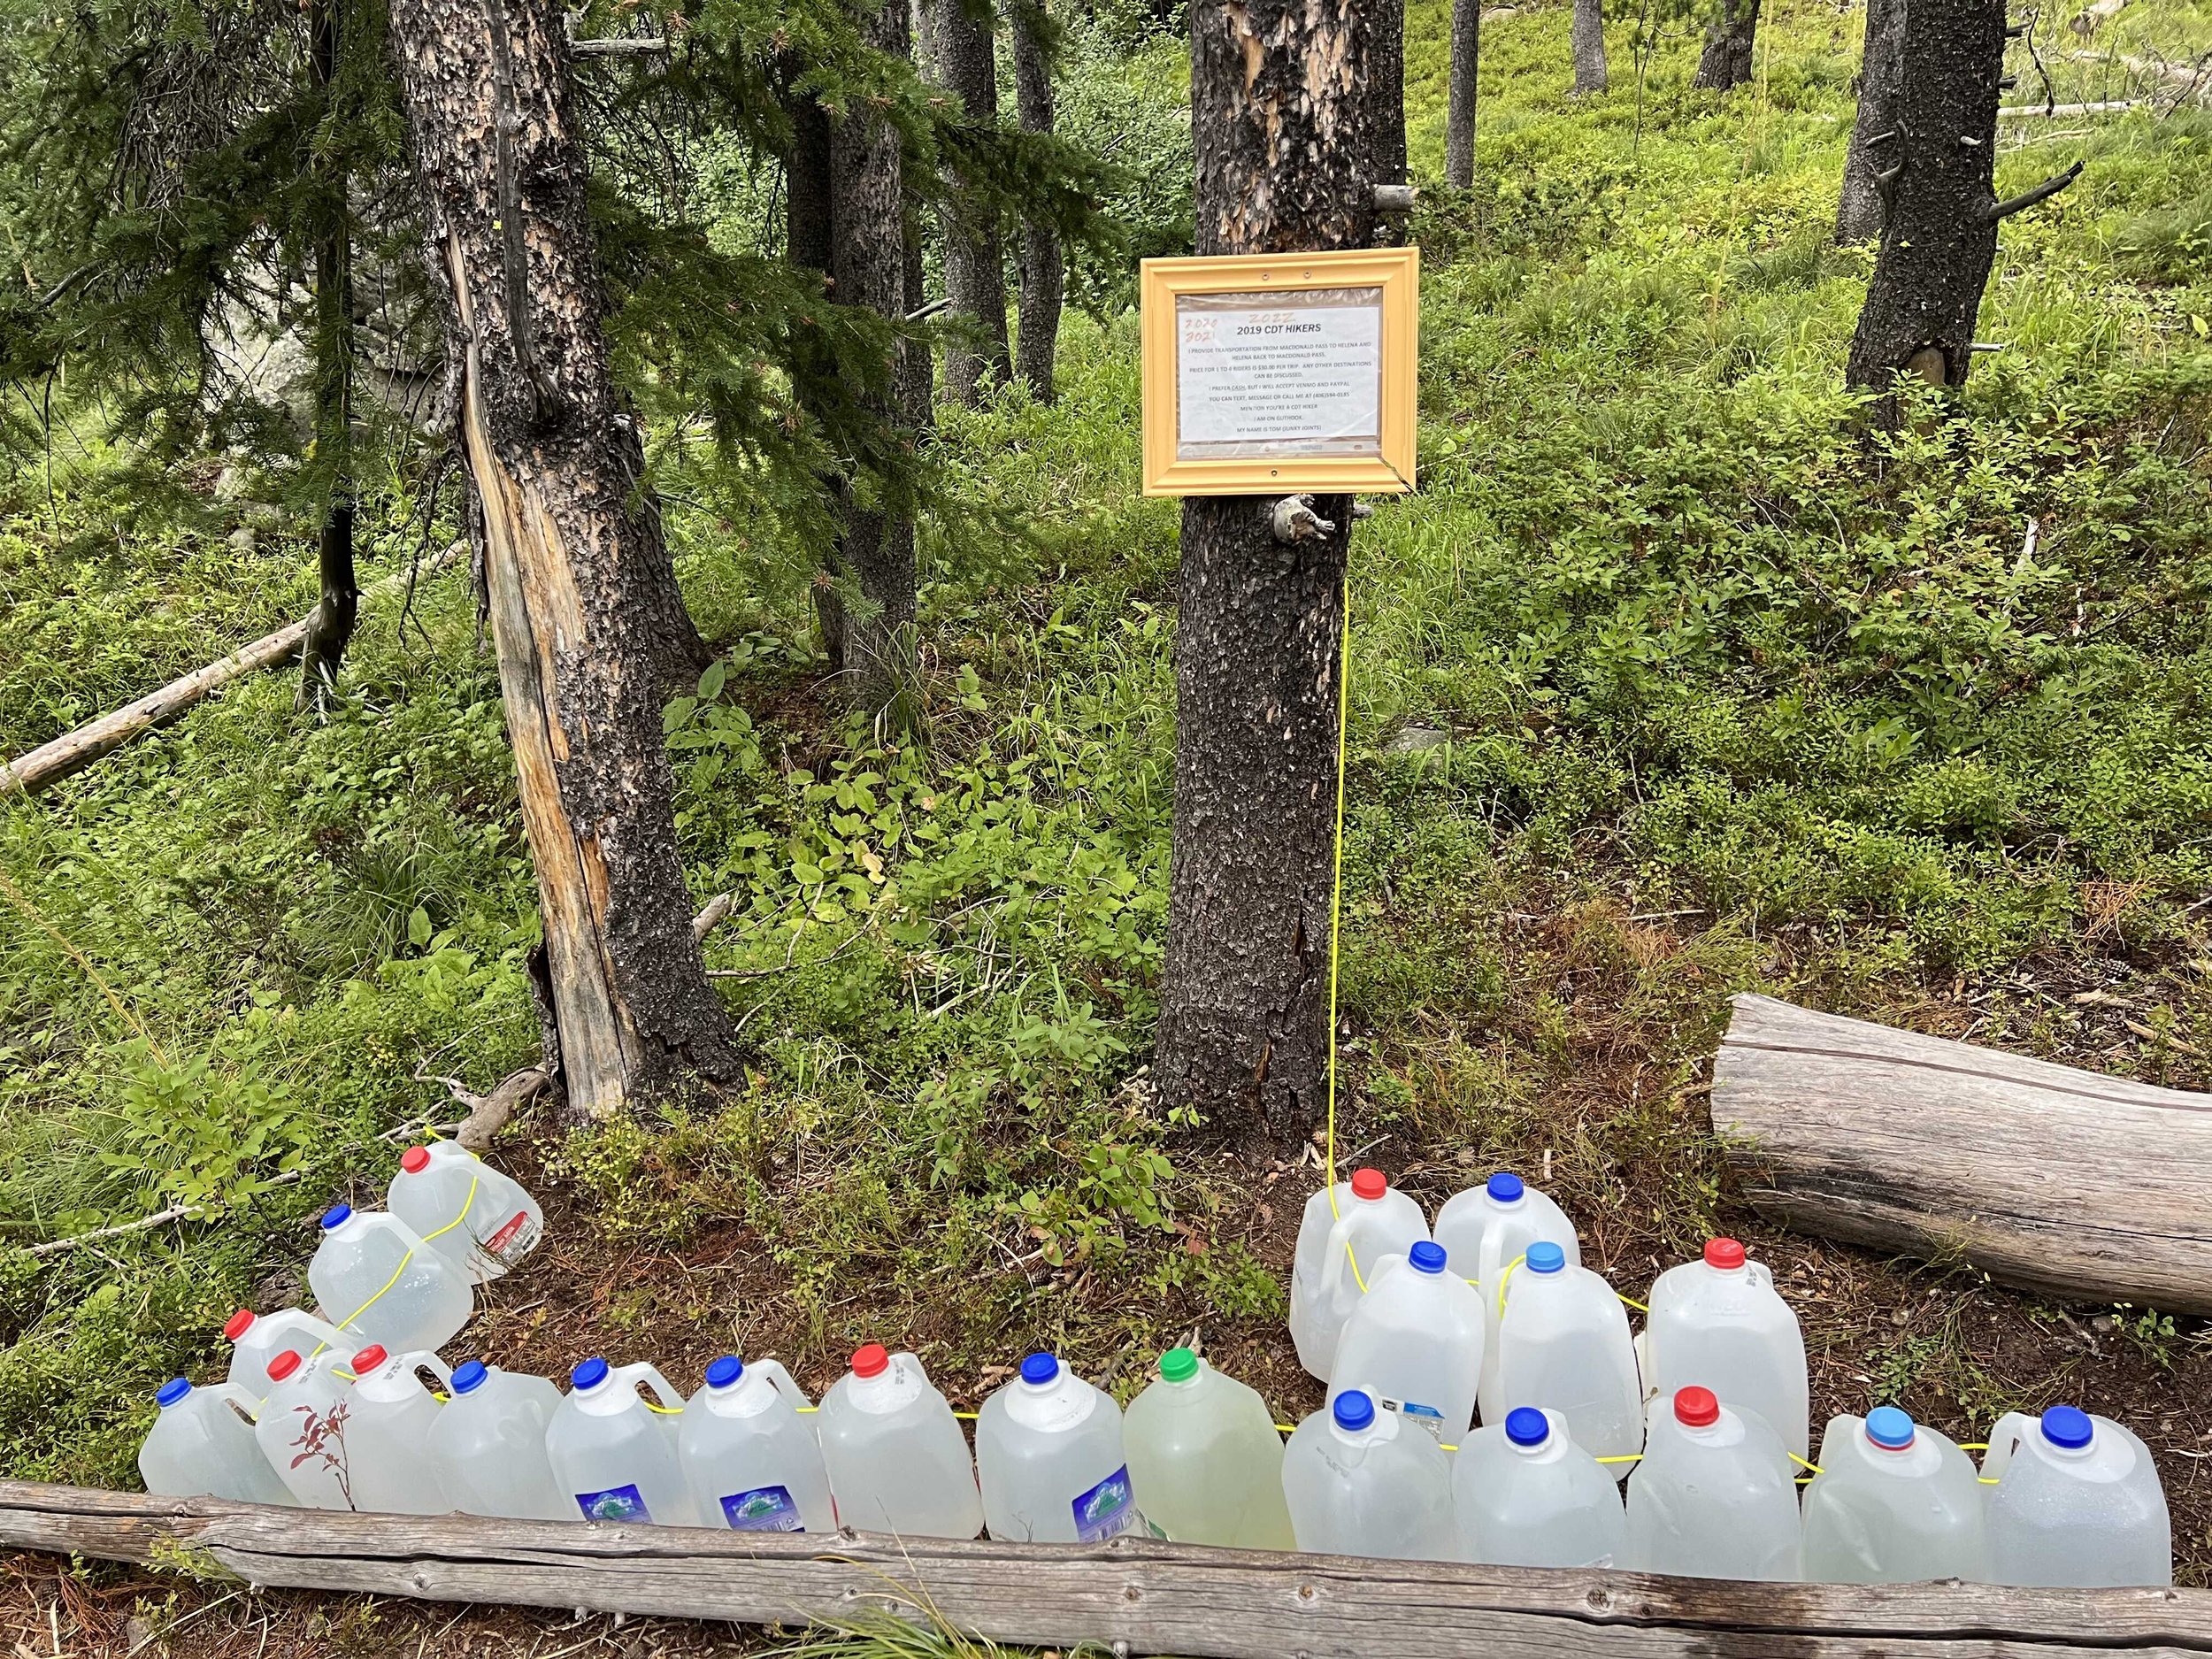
[1159,0,1376,1144]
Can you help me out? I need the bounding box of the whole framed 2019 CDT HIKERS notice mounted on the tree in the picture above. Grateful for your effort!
[1141,248,1420,495]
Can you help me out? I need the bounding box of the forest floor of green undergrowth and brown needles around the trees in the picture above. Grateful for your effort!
[0,0,2212,1659]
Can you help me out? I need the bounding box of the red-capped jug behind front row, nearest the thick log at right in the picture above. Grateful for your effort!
[1644,1239,1812,1458]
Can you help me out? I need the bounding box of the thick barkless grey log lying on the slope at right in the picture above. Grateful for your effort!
[1712,995,2212,1314]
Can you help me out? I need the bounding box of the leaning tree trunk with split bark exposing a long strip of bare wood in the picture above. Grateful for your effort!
[392,0,737,1118]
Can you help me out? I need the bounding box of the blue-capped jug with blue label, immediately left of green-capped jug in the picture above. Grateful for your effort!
[976,1354,1146,1544]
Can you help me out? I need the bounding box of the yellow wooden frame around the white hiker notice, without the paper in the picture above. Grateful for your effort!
[1140,248,1420,495]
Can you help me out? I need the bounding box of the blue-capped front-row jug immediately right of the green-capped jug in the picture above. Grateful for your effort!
[1283,1389,1460,1562]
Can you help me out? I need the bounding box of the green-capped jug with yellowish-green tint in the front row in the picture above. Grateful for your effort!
[1122,1348,1299,1551]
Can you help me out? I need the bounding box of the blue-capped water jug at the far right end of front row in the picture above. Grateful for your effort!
[1982,1405,2175,1588]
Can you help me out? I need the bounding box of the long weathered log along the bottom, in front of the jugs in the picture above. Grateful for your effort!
[0,1482,2212,1659]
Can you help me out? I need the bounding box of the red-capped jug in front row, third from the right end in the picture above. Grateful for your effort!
[1626,1387,1801,1579]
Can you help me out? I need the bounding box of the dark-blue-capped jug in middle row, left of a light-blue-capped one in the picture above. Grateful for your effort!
[1330,1239,1485,1445]
